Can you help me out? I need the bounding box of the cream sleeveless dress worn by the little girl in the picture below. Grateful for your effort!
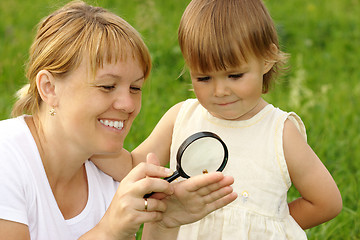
[170,99,307,240]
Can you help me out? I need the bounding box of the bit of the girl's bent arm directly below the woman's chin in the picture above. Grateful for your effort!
[90,149,133,182]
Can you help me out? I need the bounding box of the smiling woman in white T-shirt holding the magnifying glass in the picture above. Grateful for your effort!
[0,1,236,239]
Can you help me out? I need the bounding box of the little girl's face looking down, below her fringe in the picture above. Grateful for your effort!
[190,58,272,120]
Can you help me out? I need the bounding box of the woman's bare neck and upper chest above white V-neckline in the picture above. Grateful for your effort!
[25,116,88,219]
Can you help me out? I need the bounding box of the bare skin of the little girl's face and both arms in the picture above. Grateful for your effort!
[95,54,342,229]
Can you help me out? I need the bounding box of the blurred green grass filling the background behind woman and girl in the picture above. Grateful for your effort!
[0,0,360,240]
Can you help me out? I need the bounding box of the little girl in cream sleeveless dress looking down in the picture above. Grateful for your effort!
[93,0,342,237]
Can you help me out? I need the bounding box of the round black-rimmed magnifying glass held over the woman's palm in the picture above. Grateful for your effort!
[144,132,228,198]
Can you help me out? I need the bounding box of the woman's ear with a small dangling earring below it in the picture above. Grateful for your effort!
[36,70,56,106]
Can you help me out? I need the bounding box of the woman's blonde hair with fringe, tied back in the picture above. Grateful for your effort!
[12,1,151,116]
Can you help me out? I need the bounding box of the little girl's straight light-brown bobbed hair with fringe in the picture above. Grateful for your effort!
[178,0,287,93]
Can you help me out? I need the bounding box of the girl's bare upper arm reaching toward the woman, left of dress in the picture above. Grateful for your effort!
[131,103,182,166]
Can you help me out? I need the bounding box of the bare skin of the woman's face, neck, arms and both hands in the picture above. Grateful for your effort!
[0,55,236,240]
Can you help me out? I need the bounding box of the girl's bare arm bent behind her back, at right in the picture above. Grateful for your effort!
[283,120,342,229]
